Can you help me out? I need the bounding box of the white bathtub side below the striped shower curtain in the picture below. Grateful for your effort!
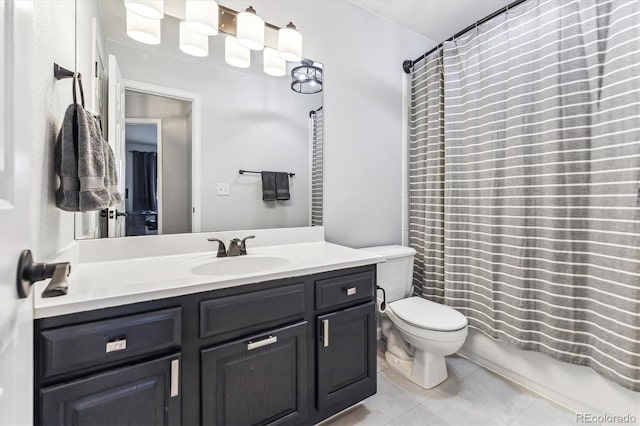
[460,330,640,418]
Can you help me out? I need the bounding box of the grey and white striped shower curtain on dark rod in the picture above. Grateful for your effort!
[410,0,640,391]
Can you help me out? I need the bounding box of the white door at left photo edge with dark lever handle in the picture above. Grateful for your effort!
[0,0,34,426]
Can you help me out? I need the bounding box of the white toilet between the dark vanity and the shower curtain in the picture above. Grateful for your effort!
[362,245,467,389]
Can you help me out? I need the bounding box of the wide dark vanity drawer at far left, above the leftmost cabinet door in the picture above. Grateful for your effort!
[39,308,182,378]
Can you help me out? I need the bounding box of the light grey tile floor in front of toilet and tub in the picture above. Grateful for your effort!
[321,351,576,426]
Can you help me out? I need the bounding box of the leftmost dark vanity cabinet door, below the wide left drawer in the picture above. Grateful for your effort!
[39,355,181,426]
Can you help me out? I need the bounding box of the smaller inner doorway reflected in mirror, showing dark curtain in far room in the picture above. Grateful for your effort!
[125,118,163,237]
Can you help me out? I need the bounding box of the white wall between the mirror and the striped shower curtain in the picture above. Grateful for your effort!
[224,0,433,247]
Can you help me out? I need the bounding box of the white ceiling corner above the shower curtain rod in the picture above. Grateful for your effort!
[351,0,513,46]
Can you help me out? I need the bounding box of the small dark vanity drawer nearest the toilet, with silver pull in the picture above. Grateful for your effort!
[315,270,374,309]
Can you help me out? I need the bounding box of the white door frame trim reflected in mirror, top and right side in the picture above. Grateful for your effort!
[124,78,202,232]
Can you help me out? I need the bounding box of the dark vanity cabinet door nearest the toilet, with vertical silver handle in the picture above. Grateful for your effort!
[317,302,376,412]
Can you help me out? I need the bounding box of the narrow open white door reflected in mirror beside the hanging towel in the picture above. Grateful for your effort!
[107,55,127,238]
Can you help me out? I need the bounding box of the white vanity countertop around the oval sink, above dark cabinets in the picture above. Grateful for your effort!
[34,241,385,318]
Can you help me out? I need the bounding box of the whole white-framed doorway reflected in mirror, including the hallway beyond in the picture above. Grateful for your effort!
[125,80,200,236]
